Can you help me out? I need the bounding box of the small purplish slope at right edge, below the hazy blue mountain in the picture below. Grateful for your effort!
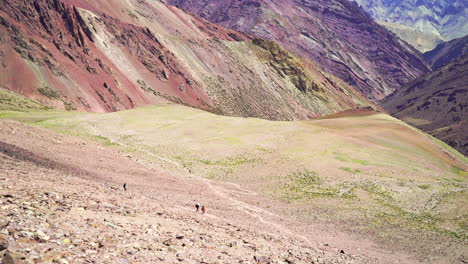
[423,35,468,69]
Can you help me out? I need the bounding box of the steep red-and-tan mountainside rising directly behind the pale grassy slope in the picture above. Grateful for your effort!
[0,0,370,120]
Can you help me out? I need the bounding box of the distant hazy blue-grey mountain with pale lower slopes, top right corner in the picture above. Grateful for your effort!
[354,0,468,52]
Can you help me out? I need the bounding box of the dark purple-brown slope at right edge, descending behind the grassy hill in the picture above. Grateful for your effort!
[382,53,468,155]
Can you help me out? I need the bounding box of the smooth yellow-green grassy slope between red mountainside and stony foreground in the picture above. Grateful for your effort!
[0,105,468,258]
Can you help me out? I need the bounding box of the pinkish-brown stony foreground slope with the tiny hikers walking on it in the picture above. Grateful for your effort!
[0,121,380,264]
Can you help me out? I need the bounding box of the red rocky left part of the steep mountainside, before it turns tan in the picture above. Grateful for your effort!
[0,0,211,112]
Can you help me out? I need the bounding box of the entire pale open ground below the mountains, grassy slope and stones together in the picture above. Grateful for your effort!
[0,106,468,263]
